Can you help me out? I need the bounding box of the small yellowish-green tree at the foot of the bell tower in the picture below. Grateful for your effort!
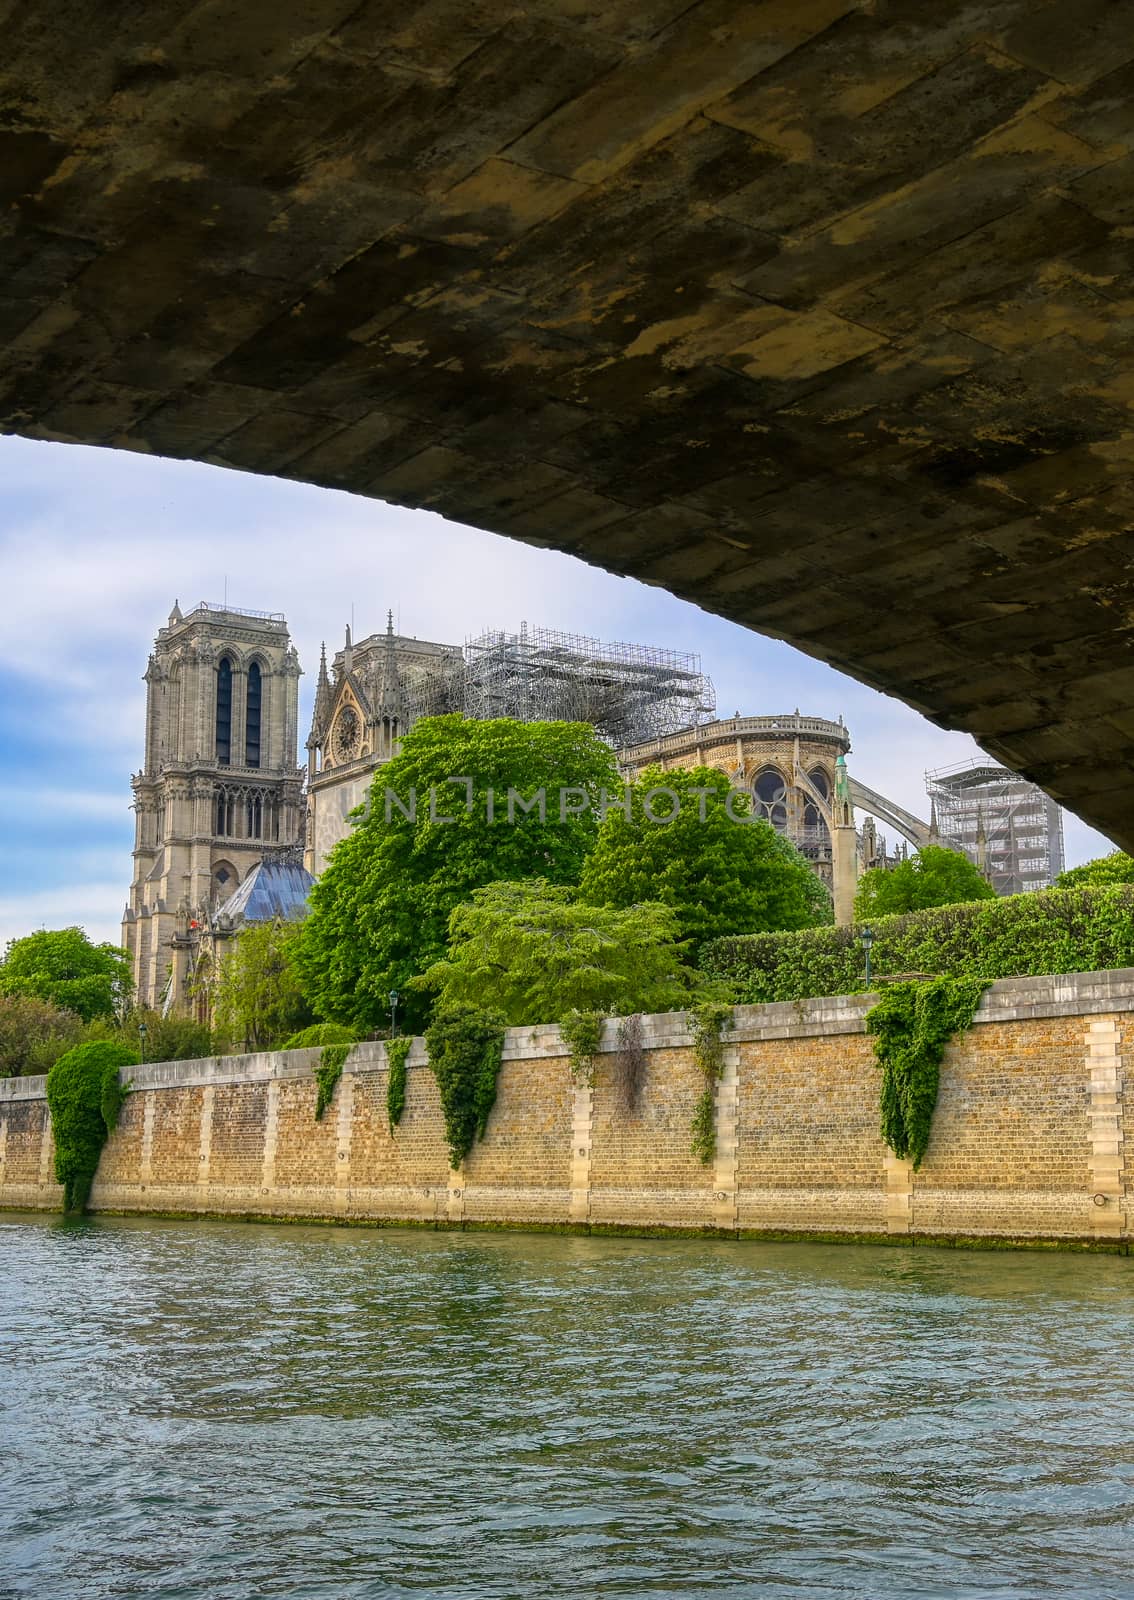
[213,917,312,1050]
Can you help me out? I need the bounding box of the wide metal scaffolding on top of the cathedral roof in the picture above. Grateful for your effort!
[462,622,715,749]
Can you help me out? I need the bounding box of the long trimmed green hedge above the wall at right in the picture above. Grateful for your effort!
[701,885,1134,1005]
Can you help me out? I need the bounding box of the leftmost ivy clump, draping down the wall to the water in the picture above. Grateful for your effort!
[46,1038,138,1211]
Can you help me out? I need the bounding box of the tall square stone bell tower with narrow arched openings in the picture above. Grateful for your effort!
[122,602,302,1011]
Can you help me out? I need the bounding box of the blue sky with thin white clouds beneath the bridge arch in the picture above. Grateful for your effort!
[0,438,1112,946]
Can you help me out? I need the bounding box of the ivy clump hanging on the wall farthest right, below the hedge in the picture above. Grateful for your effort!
[867,978,988,1171]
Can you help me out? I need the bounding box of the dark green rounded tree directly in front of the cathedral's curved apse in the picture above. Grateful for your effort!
[579,766,830,962]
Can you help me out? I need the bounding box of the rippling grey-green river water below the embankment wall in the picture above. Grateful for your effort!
[0,1216,1134,1600]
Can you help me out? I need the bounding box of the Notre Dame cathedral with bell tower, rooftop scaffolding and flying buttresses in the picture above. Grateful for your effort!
[122,602,966,1019]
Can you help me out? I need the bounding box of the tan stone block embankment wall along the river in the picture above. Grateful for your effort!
[0,970,1134,1251]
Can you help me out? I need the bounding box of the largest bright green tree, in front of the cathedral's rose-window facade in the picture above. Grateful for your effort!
[299,717,619,1032]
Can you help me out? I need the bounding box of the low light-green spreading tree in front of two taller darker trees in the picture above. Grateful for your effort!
[413,878,696,1024]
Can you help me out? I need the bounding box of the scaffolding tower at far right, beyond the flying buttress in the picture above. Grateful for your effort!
[926,760,1064,894]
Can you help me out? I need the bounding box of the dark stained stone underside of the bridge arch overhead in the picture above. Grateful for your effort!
[0,0,1134,846]
